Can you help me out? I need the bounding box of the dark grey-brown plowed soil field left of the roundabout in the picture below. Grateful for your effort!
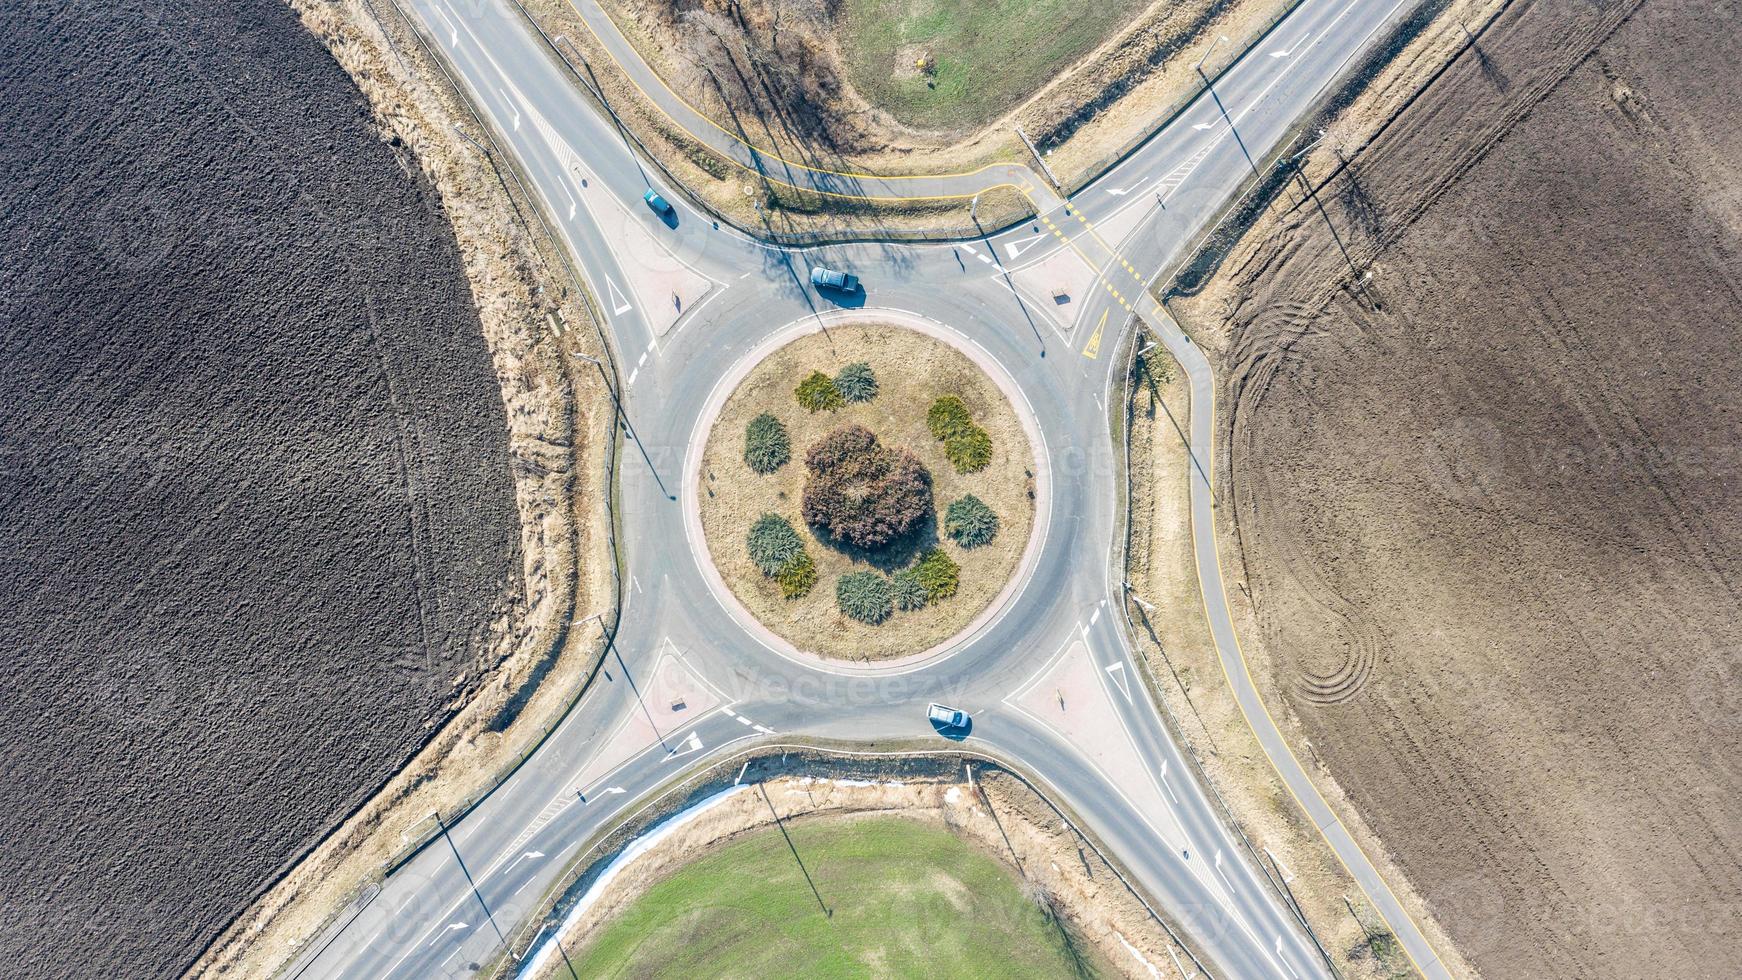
[0,0,519,977]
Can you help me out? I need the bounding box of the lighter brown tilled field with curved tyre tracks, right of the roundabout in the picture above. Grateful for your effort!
[1179,0,1742,978]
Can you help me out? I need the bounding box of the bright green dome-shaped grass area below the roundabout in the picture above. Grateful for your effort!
[556,816,1094,978]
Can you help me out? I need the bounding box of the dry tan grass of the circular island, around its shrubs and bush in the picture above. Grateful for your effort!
[700,324,1035,660]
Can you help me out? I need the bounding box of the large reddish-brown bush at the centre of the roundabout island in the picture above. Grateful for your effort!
[803,425,932,548]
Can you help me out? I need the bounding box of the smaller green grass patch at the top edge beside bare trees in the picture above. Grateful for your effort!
[840,0,1146,129]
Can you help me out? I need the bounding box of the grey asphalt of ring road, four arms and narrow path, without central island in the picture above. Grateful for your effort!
[296,0,1446,978]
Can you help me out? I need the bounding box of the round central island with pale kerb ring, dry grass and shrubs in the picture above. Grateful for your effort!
[681,310,1052,674]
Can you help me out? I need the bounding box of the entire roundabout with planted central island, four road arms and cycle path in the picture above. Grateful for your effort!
[298,0,1444,978]
